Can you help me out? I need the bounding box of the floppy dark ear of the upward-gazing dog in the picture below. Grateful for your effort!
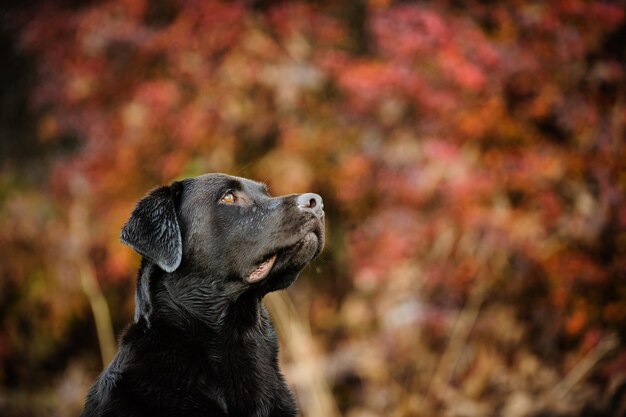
[120,182,183,272]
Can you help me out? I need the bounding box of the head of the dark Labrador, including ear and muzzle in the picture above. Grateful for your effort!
[121,174,324,291]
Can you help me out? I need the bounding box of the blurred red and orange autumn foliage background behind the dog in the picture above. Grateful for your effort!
[0,0,626,417]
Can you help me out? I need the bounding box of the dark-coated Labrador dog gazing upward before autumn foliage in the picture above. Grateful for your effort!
[82,174,324,417]
